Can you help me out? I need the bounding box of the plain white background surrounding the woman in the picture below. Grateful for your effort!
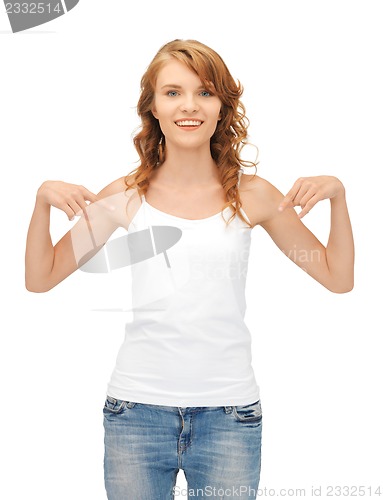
[0,0,383,500]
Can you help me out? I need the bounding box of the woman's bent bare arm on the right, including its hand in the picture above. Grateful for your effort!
[261,175,354,293]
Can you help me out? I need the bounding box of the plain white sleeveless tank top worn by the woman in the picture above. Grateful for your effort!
[107,170,260,407]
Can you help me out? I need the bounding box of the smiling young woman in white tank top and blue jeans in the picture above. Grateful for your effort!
[26,40,354,500]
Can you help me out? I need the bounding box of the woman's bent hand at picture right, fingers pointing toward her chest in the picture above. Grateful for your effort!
[278,175,344,219]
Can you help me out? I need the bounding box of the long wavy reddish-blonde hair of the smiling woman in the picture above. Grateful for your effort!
[125,39,257,227]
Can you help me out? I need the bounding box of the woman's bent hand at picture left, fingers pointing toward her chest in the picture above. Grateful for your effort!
[37,181,98,221]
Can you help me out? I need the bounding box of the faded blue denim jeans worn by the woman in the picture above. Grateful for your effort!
[103,396,262,500]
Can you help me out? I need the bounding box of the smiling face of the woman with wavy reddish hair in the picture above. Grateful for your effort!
[152,59,221,151]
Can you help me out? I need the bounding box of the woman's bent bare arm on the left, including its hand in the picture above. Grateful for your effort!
[25,177,136,292]
